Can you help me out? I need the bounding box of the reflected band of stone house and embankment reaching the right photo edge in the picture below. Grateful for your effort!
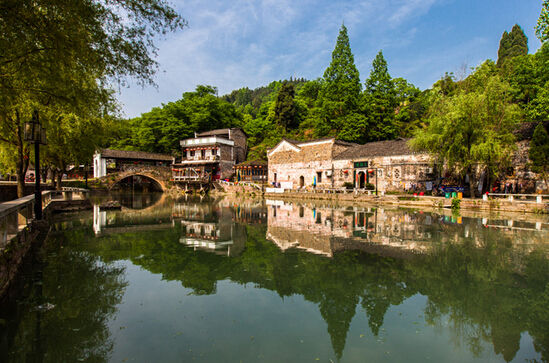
[266,200,549,257]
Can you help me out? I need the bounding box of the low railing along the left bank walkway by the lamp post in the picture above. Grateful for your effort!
[0,187,89,249]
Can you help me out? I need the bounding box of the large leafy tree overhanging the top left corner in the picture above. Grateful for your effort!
[0,0,185,196]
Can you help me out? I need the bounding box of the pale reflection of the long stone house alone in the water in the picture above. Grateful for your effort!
[267,200,440,257]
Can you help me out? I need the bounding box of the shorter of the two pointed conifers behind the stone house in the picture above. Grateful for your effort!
[363,51,398,141]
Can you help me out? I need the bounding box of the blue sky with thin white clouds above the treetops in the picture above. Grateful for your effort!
[118,0,542,117]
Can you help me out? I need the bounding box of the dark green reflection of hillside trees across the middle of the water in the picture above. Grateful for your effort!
[39,210,549,361]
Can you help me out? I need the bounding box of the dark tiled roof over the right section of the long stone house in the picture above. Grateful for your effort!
[334,139,413,160]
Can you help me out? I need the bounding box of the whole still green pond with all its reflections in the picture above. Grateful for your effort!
[0,194,549,362]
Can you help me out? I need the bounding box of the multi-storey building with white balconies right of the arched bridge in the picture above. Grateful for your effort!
[173,129,247,182]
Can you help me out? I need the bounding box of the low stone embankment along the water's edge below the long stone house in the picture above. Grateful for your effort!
[265,191,549,213]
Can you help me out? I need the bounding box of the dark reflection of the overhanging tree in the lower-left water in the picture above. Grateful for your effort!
[3,237,126,362]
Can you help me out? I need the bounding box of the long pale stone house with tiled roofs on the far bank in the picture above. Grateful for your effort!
[267,138,435,191]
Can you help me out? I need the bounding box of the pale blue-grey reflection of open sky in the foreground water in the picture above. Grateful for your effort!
[110,262,540,362]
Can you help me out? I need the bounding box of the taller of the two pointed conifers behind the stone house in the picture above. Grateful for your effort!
[318,25,362,139]
